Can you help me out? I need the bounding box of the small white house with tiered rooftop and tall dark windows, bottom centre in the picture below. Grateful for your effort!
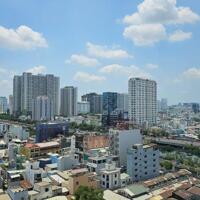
[100,161,121,189]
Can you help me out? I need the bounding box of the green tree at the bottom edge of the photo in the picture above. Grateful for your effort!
[74,186,103,200]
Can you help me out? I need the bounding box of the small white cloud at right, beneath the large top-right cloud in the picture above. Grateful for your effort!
[169,30,192,42]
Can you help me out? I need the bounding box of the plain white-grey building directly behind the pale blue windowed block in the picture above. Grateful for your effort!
[109,129,142,166]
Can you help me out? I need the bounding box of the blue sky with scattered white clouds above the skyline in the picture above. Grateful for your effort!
[0,0,200,104]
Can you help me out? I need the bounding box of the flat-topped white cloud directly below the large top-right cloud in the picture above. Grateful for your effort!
[123,24,167,46]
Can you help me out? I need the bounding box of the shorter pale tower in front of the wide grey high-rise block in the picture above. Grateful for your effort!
[32,96,54,121]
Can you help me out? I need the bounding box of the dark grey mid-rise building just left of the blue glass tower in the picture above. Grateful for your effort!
[81,92,102,114]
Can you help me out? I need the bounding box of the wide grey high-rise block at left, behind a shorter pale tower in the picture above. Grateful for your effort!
[13,72,60,115]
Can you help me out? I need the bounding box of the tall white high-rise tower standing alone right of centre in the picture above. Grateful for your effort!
[128,78,157,125]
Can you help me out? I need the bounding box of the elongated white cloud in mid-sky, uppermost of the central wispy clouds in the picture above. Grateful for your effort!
[87,42,131,59]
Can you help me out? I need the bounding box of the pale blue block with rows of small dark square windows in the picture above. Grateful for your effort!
[127,144,160,181]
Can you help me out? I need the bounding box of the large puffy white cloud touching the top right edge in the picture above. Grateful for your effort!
[123,0,200,24]
